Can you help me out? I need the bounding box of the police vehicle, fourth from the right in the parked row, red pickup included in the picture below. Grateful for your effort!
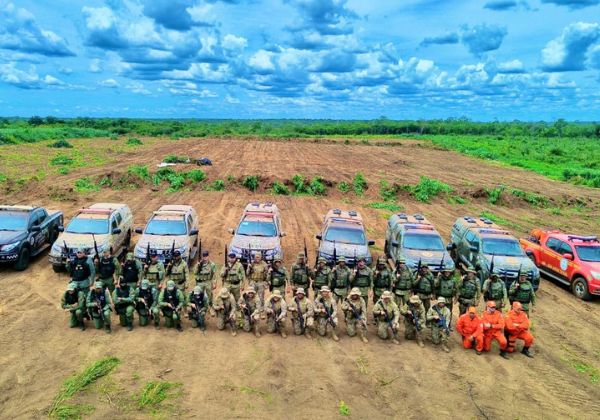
[316,209,375,267]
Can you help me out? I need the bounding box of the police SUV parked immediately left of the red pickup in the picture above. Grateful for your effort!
[450,216,540,290]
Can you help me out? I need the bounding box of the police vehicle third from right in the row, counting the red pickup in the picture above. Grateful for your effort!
[385,213,454,273]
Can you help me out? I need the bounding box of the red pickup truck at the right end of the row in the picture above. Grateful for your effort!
[519,229,600,300]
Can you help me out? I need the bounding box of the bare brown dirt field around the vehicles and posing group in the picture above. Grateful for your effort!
[0,139,600,419]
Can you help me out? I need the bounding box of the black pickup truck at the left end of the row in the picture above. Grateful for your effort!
[0,205,63,271]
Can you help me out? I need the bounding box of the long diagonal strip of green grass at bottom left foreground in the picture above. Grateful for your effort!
[48,357,121,419]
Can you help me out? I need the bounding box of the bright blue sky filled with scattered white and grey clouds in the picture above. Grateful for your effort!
[0,0,600,121]
